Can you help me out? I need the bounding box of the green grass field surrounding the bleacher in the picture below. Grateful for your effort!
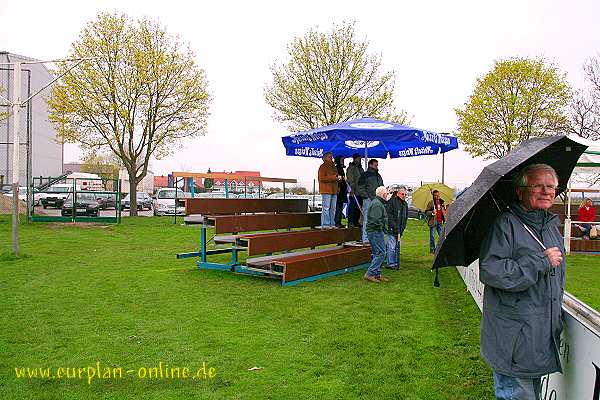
[0,216,600,399]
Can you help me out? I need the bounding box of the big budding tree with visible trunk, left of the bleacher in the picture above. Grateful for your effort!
[48,14,210,215]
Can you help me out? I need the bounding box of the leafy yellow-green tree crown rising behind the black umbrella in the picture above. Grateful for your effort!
[455,58,571,159]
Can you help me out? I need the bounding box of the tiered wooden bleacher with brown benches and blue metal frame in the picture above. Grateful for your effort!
[178,199,371,285]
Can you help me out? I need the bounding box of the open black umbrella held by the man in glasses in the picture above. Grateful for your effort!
[433,136,587,268]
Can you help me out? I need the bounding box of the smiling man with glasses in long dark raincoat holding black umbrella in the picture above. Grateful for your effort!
[479,164,566,400]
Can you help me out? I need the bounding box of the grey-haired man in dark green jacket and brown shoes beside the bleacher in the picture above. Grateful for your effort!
[364,186,389,283]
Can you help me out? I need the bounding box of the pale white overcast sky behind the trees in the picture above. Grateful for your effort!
[0,0,600,187]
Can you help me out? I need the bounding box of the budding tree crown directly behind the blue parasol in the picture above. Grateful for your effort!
[264,23,408,131]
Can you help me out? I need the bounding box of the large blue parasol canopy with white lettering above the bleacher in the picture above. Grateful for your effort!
[281,118,458,158]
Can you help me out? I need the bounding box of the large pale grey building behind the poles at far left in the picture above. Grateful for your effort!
[0,51,63,186]
